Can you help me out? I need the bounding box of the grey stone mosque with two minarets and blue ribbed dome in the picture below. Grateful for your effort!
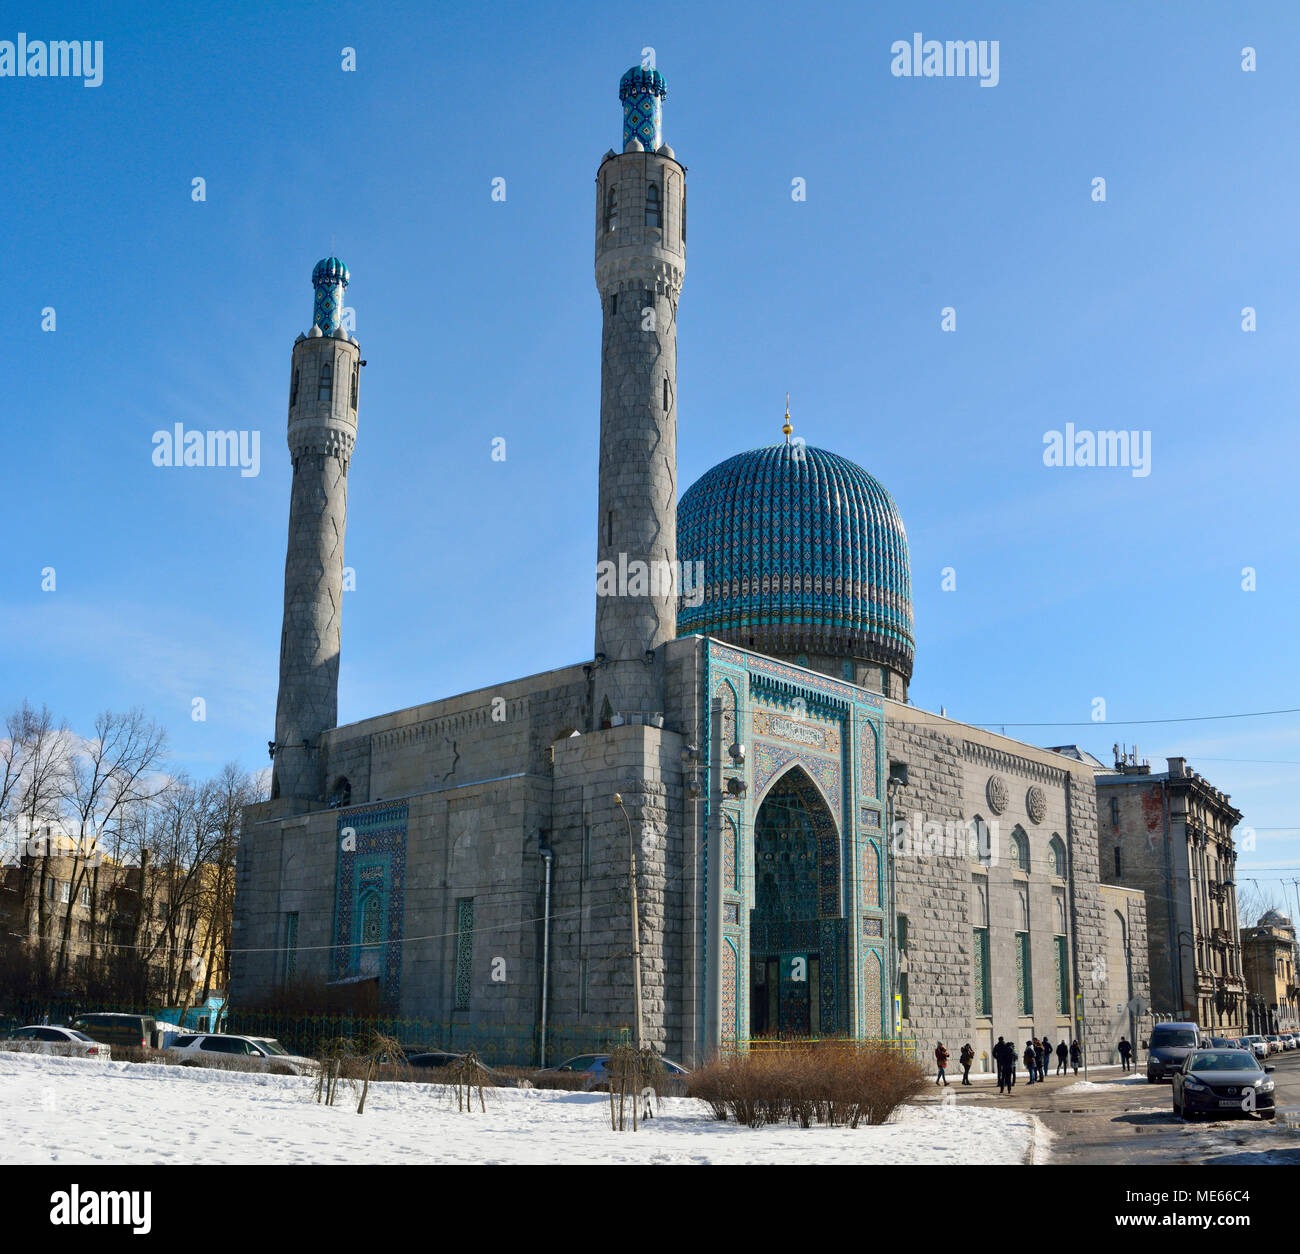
[231,66,1149,1067]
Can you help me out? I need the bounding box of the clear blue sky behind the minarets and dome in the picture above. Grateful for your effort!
[0,0,1300,904]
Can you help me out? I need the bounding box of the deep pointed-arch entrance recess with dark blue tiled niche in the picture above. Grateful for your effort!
[749,767,848,1040]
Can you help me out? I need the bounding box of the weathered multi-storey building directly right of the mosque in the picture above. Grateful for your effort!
[1096,749,1247,1034]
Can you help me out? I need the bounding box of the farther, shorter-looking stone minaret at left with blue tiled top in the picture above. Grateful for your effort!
[270,257,361,802]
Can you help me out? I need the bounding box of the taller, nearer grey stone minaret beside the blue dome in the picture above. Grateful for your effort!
[593,66,686,728]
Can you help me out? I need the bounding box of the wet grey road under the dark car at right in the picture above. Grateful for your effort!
[949,1050,1300,1166]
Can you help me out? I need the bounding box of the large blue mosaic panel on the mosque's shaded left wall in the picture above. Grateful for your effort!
[334,803,408,1006]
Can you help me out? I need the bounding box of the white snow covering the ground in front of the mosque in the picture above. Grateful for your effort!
[0,1054,1048,1166]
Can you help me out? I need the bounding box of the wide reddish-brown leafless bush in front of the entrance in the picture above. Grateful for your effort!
[686,1042,926,1128]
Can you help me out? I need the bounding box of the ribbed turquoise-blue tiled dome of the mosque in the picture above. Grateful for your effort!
[677,443,914,680]
